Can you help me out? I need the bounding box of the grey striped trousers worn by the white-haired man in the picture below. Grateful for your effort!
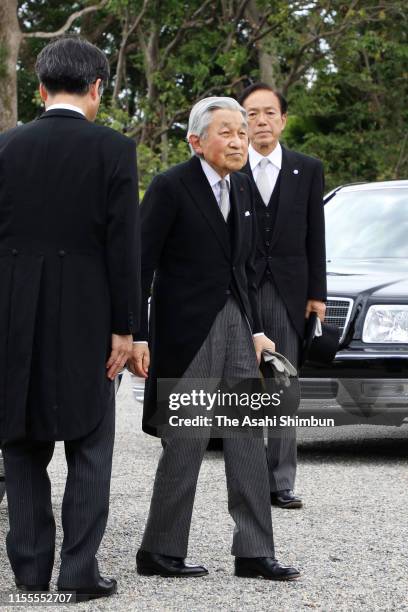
[141,298,274,558]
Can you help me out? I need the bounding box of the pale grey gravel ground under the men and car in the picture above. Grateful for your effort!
[0,376,408,612]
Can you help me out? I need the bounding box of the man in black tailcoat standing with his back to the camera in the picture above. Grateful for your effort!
[0,37,140,600]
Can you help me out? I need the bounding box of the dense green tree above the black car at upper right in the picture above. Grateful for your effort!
[286,2,408,188]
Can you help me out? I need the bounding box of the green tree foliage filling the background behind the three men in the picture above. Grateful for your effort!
[9,0,408,190]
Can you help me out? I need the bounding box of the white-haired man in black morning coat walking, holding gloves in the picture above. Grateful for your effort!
[132,98,299,580]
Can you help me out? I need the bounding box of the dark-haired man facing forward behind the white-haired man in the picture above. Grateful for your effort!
[239,83,327,508]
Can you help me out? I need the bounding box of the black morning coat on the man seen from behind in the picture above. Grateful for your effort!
[0,109,140,440]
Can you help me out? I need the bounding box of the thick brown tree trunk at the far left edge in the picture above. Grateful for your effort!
[0,0,22,132]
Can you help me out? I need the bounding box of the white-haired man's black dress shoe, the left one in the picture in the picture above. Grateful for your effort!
[136,550,208,578]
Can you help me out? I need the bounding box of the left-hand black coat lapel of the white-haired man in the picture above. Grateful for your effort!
[181,156,231,259]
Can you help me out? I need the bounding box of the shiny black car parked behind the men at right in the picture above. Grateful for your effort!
[301,180,408,425]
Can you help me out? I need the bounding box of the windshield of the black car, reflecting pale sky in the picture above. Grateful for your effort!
[325,188,408,259]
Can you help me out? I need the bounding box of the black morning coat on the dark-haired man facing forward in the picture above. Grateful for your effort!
[242,147,327,340]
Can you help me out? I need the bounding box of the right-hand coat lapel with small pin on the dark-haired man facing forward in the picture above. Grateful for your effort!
[271,147,302,248]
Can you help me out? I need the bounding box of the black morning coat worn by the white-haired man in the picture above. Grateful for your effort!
[135,157,262,435]
